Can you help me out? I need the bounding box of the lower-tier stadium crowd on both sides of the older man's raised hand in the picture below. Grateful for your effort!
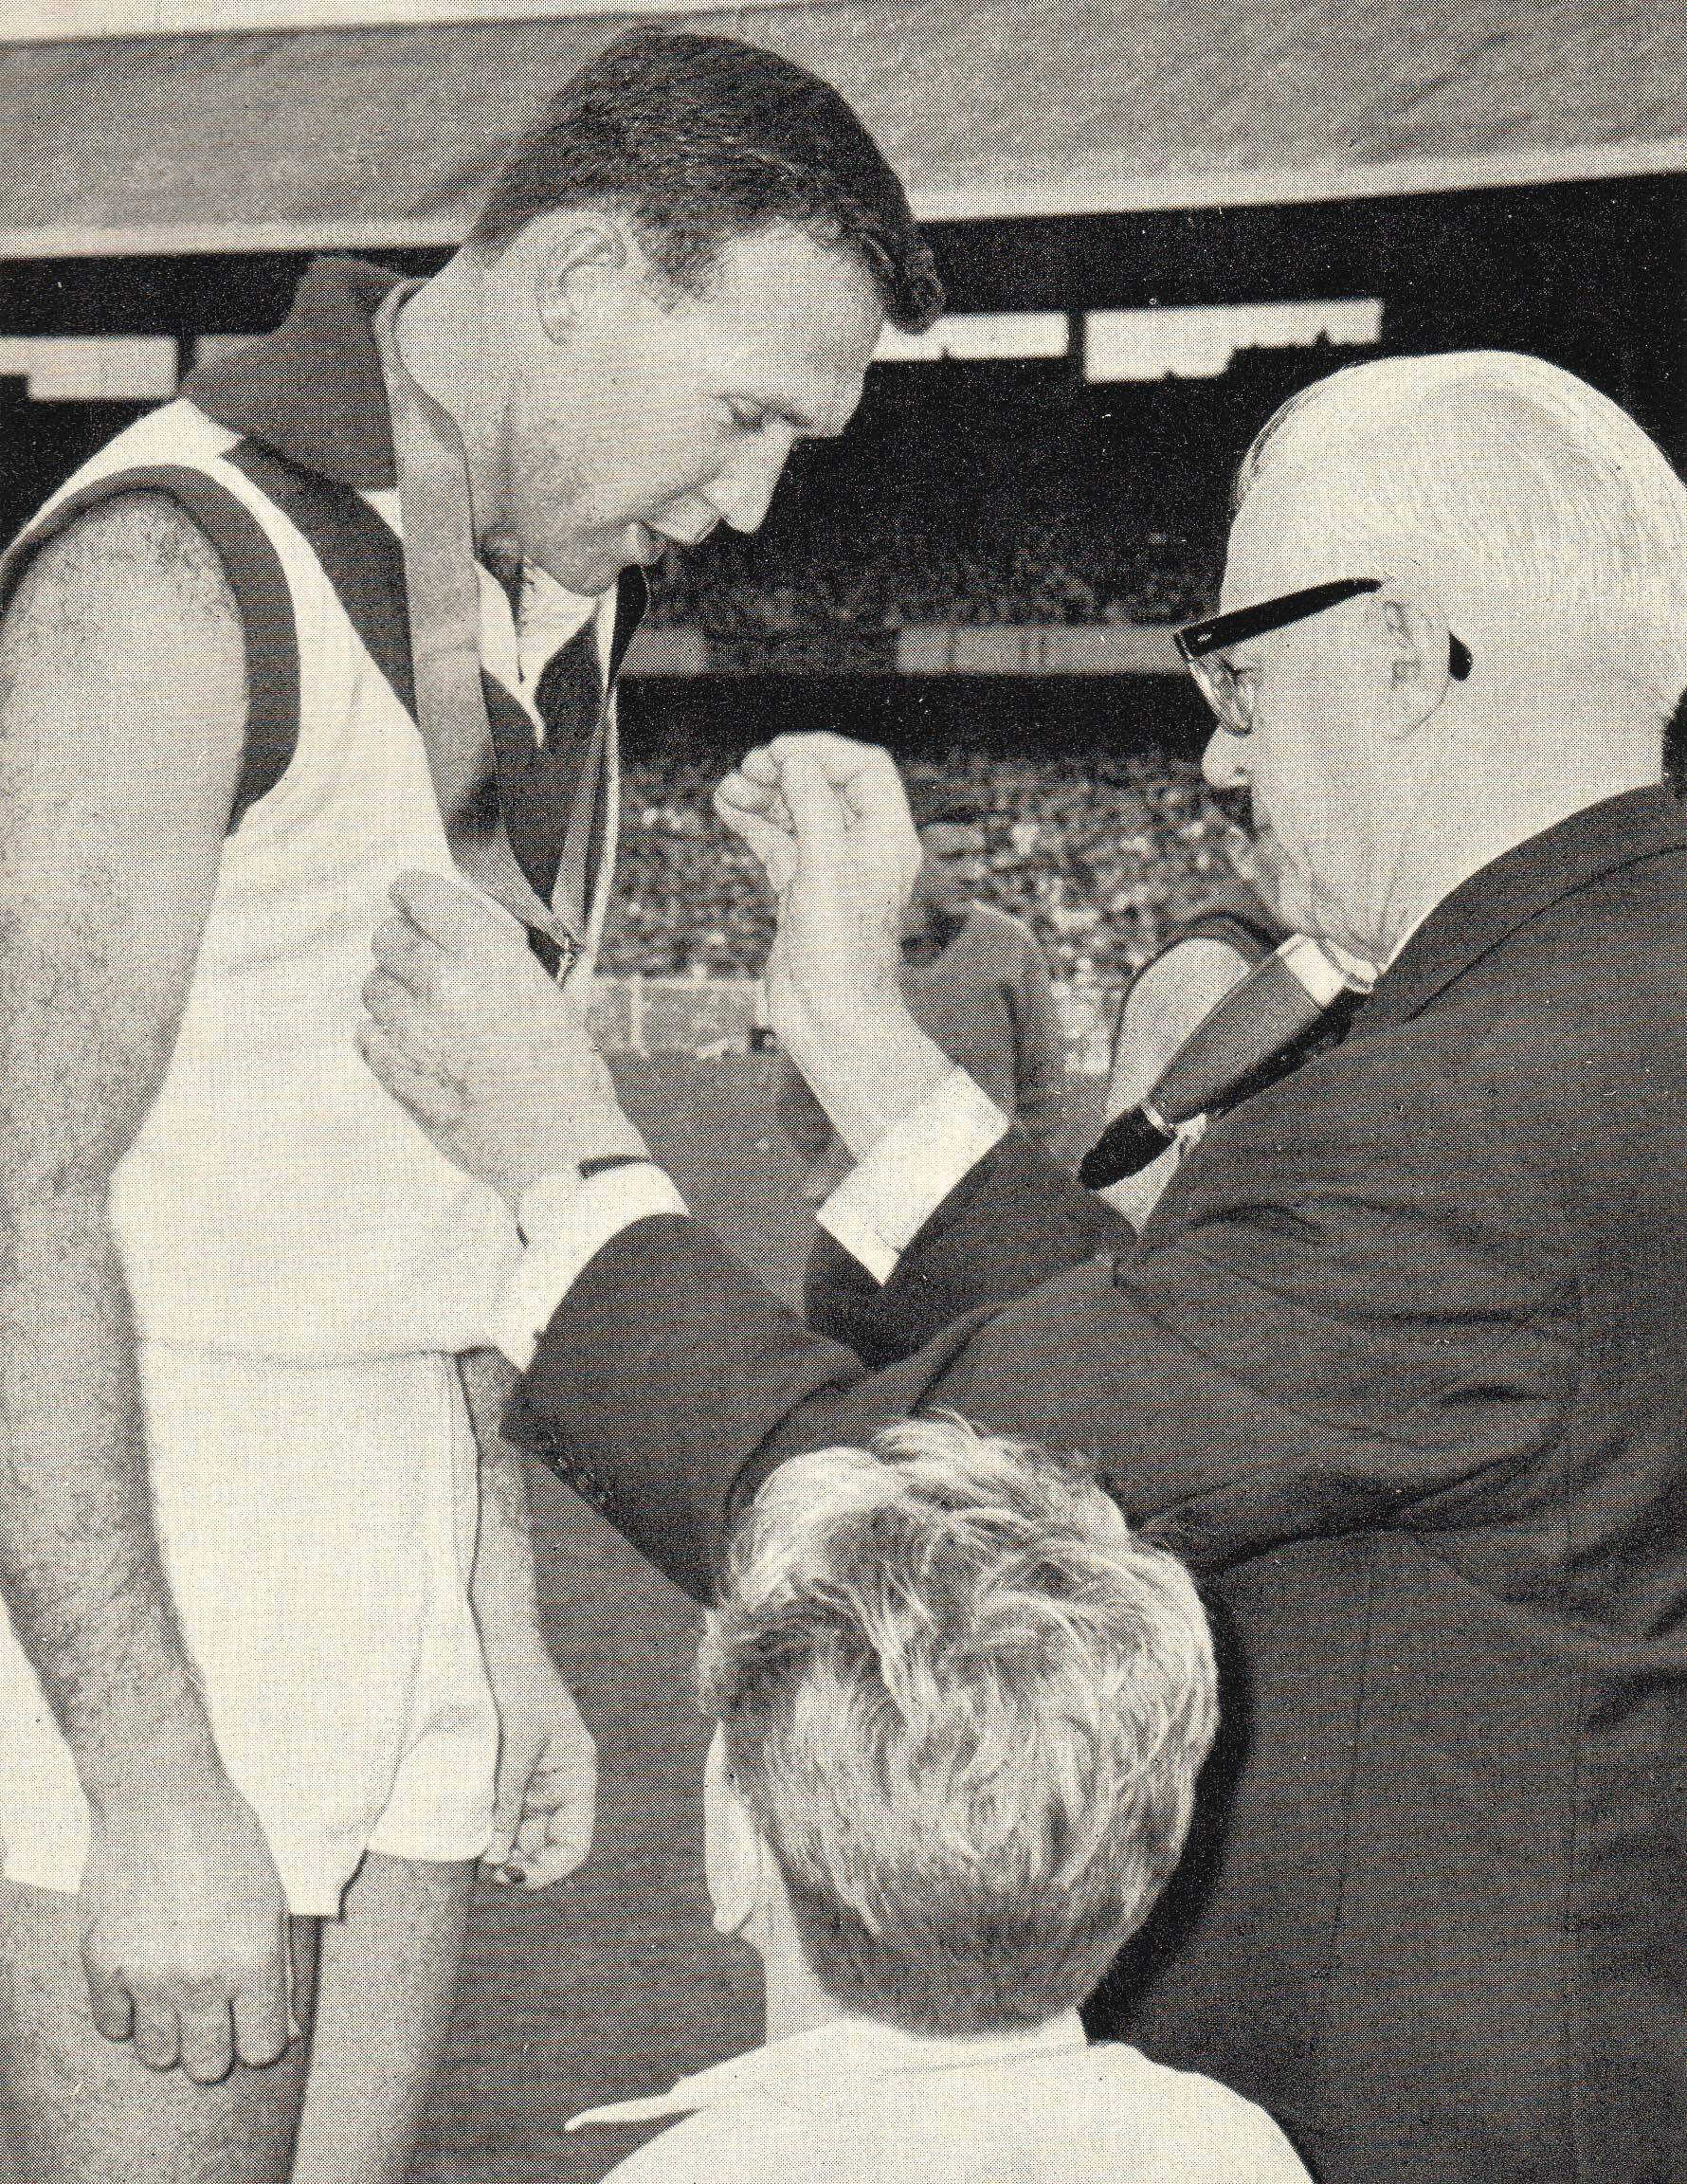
[603,752,1242,987]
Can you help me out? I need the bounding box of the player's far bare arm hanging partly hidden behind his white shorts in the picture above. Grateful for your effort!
[461,1350,598,1889]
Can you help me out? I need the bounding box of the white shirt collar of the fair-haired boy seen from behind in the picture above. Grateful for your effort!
[565,2010,1089,2132]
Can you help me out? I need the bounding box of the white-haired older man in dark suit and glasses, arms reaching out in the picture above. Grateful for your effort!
[367,354,1687,2184]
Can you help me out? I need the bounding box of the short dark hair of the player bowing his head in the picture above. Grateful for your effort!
[469,30,943,332]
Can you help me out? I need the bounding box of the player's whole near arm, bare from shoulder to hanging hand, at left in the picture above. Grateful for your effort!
[0,496,288,2082]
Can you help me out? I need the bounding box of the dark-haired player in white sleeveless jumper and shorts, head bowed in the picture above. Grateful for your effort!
[0,33,938,2184]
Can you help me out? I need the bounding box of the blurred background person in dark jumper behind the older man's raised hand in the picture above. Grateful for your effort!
[774,792,1065,1206]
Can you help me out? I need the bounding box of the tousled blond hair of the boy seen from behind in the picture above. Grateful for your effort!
[698,1420,1218,2033]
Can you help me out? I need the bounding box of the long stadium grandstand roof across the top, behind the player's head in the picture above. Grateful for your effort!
[0,0,1687,258]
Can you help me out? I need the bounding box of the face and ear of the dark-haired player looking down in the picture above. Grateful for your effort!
[506,225,884,594]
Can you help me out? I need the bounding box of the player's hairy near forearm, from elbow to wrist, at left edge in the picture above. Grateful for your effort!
[0,1191,216,1804]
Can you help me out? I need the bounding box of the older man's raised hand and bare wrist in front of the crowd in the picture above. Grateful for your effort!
[714,734,950,1157]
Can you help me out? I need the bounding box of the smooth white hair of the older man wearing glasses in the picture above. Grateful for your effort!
[1235,350,1687,717]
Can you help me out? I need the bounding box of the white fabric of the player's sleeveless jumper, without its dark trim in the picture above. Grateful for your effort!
[32,402,613,1363]
